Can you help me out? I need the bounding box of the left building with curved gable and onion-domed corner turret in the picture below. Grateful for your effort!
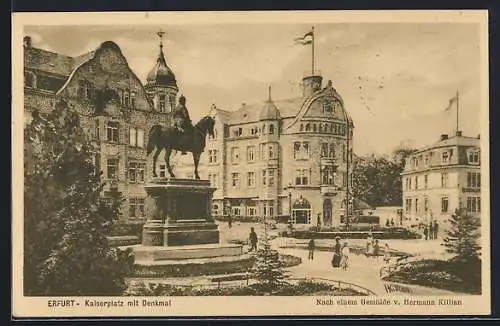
[24,36,178,222]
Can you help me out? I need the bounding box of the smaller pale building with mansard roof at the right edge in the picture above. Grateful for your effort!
[401,131,481,225]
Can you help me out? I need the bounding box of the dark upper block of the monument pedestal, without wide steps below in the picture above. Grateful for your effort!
[142,178,219,246]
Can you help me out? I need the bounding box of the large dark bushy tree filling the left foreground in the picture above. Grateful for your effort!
[24,100,133,295]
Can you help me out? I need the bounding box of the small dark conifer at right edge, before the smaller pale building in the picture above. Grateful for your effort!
[443,209,481,264]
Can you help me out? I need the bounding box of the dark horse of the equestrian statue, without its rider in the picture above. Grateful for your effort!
[147,116,215,179]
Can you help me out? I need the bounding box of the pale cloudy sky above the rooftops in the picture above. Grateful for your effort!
[25,23,481,155]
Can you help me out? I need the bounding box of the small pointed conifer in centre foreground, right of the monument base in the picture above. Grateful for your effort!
[253,219,288,294]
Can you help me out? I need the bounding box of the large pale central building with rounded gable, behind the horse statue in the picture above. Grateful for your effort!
[175,74,354,226]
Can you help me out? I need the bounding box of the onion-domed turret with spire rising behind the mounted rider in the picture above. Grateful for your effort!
[144,31,179,112]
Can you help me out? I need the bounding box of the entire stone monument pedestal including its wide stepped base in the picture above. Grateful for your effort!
[134,179,250,277]
